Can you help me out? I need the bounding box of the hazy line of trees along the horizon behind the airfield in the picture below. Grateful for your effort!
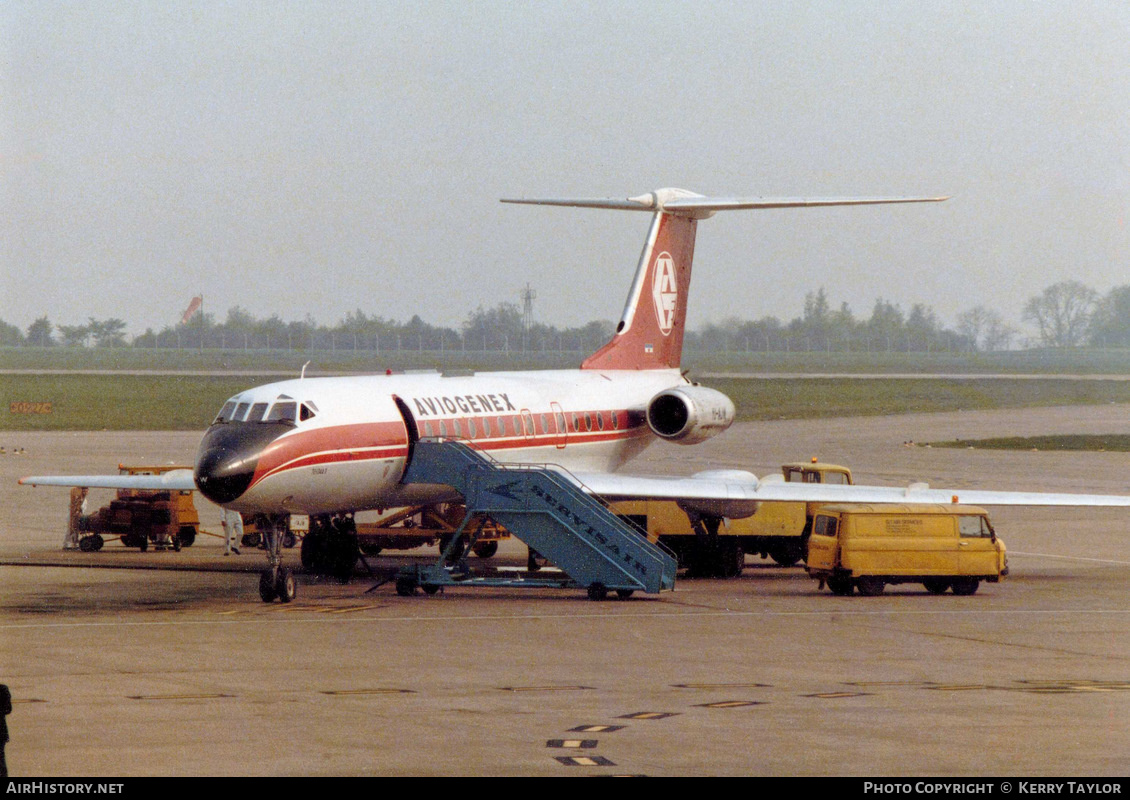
[0,281,1130,353]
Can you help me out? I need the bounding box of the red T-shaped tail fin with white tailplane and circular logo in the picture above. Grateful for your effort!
[503,189,947,369]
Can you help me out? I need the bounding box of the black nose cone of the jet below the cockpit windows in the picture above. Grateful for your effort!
[193,423,279,505]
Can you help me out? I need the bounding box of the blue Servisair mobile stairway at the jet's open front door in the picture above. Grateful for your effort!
[397,438,677,600]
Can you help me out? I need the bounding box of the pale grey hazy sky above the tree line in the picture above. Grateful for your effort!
[0,0,1130,333]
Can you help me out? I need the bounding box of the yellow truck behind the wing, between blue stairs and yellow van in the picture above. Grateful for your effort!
[610,459,852,577]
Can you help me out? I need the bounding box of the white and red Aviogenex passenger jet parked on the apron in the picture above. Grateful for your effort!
[20,189,1130,601]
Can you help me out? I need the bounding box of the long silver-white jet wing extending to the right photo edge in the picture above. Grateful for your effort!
[573,470,1130,518]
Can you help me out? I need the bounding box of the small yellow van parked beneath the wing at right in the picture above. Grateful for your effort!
[806,505,1008,595]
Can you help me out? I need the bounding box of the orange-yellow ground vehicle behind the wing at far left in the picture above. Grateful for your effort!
[72,464,200,553]
